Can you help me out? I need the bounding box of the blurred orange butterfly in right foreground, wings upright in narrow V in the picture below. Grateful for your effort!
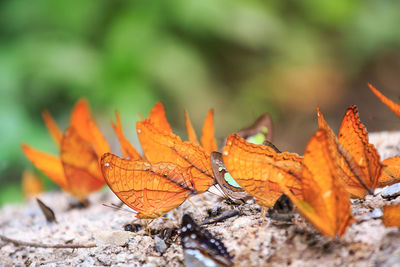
[280,129,353,238]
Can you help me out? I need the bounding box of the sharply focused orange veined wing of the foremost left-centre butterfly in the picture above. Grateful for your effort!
[101,153,194,219]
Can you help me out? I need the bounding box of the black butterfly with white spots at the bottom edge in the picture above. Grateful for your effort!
[180,214,233,267]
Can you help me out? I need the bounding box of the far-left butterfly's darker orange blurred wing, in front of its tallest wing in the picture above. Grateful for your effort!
[60,126,105,199]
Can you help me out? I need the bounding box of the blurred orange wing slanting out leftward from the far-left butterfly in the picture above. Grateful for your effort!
[21,144,68,188]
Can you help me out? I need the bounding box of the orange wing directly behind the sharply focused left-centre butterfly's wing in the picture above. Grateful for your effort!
[136,120,215,193]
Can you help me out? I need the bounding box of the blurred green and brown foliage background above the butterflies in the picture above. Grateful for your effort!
[0,0,400,205]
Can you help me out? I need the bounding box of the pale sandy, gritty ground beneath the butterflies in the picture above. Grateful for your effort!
[0,132,400,266]
